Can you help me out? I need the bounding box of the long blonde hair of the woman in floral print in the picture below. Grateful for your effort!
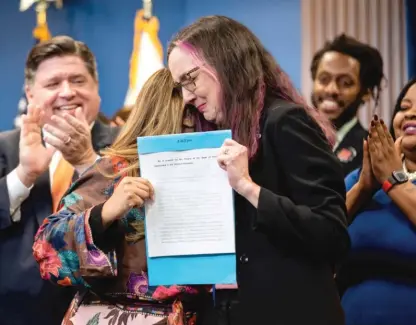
[101,68,185,177]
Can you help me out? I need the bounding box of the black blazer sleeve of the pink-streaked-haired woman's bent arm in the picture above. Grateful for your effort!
[256,108,350,261]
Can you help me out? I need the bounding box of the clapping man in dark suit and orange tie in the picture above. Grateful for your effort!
[0,36,118,325]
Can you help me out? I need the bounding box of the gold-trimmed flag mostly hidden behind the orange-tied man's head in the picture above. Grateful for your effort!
[14,0,53,128]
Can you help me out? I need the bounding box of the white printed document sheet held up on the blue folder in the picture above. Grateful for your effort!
[140,148,235,257]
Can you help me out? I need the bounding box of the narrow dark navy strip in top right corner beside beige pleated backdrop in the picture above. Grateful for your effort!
[406,0,416,79]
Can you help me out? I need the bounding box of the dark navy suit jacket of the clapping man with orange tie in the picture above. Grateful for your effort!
[0,121,118,325]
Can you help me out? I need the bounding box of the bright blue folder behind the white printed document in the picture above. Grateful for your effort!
[137,130,237,286]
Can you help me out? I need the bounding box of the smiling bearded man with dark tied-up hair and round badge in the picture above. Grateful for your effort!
[311,34,384,175]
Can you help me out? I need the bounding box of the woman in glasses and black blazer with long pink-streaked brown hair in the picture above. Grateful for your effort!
[168,16,350,325]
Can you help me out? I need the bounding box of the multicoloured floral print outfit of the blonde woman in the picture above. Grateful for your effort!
[33,158,207,325]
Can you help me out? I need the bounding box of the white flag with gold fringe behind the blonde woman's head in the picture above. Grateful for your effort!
[124,9,163,106]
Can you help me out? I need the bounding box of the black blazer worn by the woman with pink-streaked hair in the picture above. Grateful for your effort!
[206,100,350,325]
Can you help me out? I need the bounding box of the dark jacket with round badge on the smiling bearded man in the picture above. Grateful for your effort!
[335,122,368,176]
